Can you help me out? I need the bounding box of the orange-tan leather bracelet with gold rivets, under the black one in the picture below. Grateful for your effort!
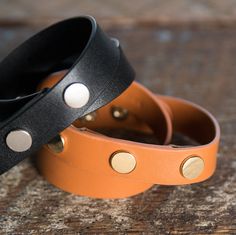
[37,71,220,198]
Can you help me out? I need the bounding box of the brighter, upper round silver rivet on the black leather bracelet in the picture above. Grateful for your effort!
[64,83,90,108]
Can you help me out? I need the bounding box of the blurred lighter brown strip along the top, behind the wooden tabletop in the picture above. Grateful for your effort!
[0,0,236,25]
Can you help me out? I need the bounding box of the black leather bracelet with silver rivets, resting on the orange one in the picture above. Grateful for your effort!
[0,16,134,173]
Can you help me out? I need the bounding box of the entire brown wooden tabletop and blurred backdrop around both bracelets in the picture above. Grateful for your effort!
[0,0,236,234]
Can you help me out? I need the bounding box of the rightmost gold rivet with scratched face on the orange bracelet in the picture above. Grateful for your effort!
[181,156,204,179]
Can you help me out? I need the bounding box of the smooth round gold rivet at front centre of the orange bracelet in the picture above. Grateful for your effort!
[110,152,136,174]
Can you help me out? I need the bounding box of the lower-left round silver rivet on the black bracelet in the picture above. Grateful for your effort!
[6,130,32,152]
